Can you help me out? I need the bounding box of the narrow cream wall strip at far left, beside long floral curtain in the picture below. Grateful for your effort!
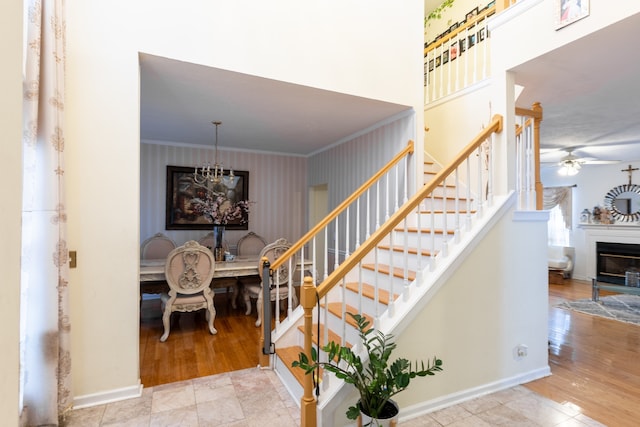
[0,1,22,426]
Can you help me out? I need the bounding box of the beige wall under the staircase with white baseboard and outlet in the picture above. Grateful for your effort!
[333,198,549,425]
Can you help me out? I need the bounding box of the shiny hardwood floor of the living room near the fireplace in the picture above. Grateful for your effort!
[525,280,640,427]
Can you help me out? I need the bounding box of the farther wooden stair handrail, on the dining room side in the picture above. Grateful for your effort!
[271,140,414,271]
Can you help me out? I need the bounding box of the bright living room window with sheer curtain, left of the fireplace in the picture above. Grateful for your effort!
[542,186,574,246]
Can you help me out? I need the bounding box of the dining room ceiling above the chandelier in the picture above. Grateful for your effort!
[140,54,411,155]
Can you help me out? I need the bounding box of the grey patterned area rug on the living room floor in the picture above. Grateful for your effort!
[556,294,640,325]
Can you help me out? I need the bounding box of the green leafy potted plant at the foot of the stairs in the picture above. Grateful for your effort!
[292,313,442,425]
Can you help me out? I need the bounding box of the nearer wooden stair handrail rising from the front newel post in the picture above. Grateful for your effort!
[316,115,503,298]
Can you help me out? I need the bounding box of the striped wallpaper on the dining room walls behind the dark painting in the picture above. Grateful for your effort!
[140,114,415,254]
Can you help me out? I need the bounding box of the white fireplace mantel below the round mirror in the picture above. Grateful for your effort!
[578,223,640,279]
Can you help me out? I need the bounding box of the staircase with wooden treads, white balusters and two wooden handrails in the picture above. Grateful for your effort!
[250,116,510,425]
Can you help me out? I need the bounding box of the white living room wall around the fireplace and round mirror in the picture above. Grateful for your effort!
[540,160,640,280]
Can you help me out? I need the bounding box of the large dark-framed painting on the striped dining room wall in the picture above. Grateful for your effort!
[165,166,249,230]
